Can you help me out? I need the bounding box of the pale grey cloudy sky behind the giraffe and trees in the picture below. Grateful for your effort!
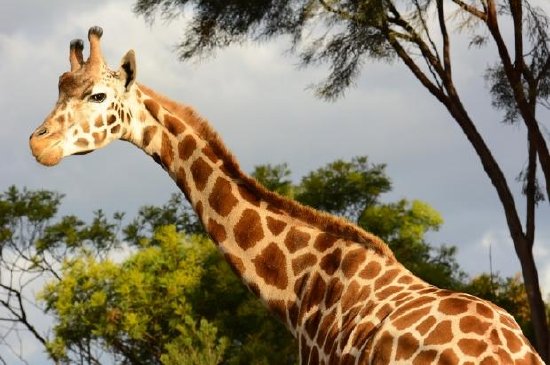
[0,0,550,363]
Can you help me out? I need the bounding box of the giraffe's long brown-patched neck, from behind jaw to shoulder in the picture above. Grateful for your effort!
[125,85,408,347]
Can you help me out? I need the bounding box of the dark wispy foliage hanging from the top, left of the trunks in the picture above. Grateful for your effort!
[134,0,394,99]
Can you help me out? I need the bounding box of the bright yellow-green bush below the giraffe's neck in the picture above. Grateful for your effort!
[41,226,228,364]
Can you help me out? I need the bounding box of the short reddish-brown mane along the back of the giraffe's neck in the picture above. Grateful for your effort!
[139,84,395,261]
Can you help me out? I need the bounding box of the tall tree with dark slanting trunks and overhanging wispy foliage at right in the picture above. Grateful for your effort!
[134,0,550,362]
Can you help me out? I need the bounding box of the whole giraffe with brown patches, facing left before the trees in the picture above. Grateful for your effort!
[30,27,543,365]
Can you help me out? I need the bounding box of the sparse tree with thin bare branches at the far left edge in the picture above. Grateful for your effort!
[0,186,122,363]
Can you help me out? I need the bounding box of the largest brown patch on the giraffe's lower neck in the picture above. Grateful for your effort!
[252,242,288,289]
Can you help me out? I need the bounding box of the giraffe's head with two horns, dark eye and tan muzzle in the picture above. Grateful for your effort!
[30,27,136,166]
